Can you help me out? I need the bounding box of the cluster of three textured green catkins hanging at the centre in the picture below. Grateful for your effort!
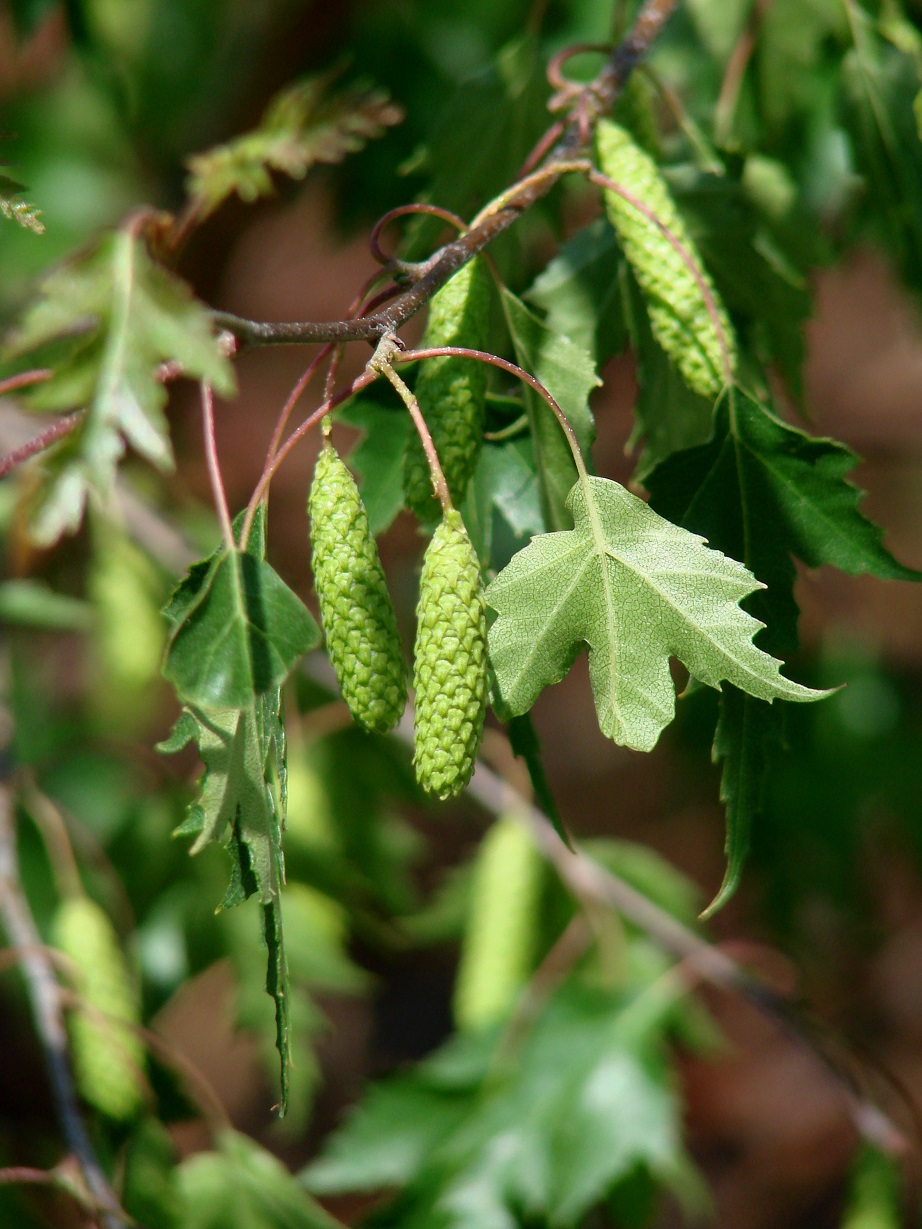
[307,261,488,798]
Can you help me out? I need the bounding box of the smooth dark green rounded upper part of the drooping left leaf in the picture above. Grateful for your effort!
[164,551,320,708]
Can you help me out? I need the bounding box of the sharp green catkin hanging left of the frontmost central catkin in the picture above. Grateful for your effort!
[307,444,407,734]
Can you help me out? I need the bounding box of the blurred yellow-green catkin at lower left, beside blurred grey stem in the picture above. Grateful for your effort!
[52,896,144,1121]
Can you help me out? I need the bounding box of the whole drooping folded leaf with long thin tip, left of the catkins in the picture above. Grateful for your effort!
[159,511,303,1115]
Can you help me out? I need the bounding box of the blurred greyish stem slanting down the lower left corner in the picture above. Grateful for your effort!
[0,785,127,1229]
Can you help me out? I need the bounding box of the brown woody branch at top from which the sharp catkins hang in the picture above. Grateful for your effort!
[213,0,679,345]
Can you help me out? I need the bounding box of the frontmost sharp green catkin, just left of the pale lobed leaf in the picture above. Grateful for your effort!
[413,508,487,798]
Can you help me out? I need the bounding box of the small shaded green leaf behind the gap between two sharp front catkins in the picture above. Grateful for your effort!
[337,393,412,537]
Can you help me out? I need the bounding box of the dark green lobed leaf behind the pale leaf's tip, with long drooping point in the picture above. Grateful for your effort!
[644,390,920,912]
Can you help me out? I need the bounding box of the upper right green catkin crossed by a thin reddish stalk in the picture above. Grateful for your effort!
[596,120,736,399]
